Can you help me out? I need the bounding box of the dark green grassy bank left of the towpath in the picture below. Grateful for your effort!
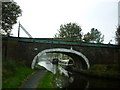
[2,60,35,88]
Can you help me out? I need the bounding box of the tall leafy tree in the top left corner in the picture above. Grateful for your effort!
[1,1,22,36]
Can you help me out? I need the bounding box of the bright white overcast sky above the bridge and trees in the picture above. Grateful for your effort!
[12,0,119,44]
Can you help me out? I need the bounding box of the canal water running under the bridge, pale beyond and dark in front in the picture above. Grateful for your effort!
[38,60,120,89]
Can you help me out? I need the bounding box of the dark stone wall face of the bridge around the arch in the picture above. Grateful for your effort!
[2,39,120,65]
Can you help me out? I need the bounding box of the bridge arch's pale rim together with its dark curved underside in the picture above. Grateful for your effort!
[31,48,90,71]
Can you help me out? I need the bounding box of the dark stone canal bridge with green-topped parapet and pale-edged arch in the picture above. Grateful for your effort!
[2,37,120,71]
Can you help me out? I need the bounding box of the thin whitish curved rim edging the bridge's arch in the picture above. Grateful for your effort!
[31,48,90,69]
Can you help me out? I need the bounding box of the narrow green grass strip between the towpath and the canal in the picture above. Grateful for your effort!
[38,72,57,88]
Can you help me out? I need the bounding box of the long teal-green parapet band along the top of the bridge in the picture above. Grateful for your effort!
[3,37,120,48]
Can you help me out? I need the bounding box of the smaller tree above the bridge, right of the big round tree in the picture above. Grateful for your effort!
[83,28,104,43]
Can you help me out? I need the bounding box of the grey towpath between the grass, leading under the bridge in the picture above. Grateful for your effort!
[20,70,45,88]
